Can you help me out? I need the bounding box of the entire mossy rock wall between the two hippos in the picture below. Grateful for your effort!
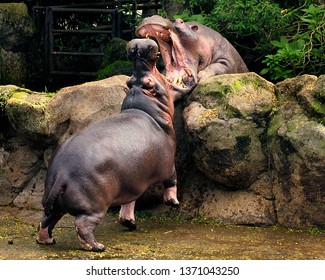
[0,73,325,228]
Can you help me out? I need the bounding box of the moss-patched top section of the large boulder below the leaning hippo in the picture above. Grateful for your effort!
[191,73,277,119]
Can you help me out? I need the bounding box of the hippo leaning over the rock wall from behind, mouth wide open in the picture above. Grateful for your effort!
[136,15,248,93]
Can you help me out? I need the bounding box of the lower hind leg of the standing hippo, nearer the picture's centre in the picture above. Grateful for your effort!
[75,212,106,252]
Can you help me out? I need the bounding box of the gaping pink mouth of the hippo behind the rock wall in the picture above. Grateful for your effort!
[136,15,197,93]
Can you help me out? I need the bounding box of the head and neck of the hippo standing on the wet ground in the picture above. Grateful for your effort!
[121,39,177,134]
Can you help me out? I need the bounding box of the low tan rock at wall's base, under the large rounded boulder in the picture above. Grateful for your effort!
[180,170,276,226]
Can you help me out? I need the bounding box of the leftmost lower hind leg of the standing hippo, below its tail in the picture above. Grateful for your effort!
[36,213,64,245]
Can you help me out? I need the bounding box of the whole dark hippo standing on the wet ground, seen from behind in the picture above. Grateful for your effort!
[36,39,177,252]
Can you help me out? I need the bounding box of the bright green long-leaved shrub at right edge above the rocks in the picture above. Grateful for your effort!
[261,4,325,80]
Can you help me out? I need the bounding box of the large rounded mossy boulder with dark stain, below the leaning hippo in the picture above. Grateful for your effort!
[184,73,276,189]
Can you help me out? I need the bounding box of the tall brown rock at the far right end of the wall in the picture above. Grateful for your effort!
[268,75,325,228]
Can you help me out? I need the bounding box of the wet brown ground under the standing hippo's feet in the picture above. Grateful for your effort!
[0,208,325,260]
